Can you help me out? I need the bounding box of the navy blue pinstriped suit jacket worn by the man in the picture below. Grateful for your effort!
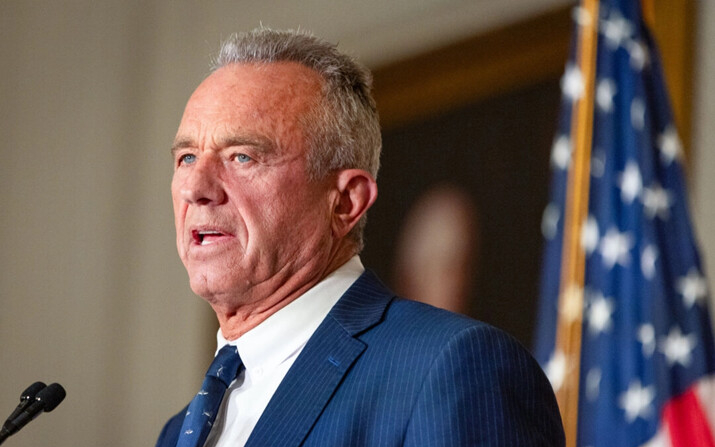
[157,272,564,447]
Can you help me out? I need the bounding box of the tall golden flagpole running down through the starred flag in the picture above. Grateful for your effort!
[556,0,599,447]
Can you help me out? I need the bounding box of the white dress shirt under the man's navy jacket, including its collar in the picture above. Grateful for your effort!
[204,256,365,447]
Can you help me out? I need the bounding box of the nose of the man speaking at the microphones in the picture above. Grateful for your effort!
[175,156,226,205]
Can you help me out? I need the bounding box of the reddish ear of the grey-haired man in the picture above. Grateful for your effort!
[332,169,377,238]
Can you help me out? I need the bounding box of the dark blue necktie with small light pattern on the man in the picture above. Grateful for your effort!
[176,345,243,447]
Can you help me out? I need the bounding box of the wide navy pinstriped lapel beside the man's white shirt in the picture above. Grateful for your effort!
[246,271,393,447]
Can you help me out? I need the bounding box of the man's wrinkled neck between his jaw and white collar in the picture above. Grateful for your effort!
[211,246,355,341]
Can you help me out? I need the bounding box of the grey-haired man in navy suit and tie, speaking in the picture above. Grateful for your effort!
[157,29,563,447]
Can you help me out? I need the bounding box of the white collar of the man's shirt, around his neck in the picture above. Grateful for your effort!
[216,255,365,369]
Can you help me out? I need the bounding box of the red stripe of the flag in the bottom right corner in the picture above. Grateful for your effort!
[663,388,715,447]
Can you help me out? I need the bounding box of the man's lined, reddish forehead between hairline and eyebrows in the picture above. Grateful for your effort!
[172,63,323,161]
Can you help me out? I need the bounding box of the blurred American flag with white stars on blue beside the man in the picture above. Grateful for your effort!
[535,0,715,447]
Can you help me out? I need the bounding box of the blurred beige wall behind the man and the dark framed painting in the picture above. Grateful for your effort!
[0,0,715,447]
